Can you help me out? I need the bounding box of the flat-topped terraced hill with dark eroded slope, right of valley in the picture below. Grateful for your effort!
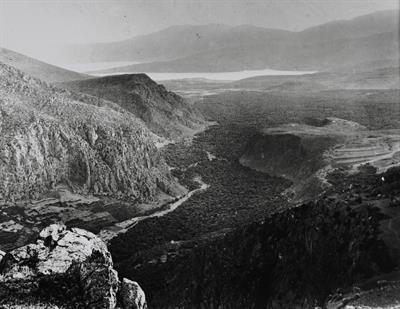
[240,117,400,201]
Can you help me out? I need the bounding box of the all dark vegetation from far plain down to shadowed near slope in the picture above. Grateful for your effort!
[110,91,400,308]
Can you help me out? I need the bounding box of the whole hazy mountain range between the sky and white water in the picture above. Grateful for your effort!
[68,11,399,74]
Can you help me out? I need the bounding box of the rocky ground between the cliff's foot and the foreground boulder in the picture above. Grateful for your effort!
[0,187,186,251]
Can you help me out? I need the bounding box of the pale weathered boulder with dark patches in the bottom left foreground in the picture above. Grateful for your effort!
[0,224,147,309]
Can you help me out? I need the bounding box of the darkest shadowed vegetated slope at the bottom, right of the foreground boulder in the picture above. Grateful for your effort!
[111,191,393,308]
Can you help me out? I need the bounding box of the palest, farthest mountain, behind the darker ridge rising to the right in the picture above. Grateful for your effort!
[60,24,291,62]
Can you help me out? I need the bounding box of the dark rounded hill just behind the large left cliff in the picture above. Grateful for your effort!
[62,74,204,138]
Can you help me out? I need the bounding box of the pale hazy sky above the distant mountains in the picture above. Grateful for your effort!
[0,0,399,59]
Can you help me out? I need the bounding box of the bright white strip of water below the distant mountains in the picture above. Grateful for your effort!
[92,69,315,81]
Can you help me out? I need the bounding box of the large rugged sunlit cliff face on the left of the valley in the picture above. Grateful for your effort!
[0,63,180,200]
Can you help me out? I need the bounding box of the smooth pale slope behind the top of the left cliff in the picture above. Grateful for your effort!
[0,47,89,83]
